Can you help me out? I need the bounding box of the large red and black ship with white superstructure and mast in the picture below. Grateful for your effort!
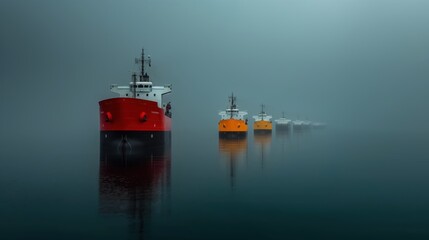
[99,49,171,148]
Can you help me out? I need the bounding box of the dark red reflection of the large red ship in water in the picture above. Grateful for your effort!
[99,138,171,238]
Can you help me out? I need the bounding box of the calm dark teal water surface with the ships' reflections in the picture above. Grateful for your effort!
[0,128,429,239]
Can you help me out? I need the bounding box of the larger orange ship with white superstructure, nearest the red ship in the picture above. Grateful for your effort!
[218,94,247,138]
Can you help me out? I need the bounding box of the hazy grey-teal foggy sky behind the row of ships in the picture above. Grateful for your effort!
[0,0,429,144]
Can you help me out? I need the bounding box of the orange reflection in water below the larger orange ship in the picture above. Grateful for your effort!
[219,135,247,187]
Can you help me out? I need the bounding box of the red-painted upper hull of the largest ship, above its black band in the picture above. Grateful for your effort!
[99,97,171,132]
